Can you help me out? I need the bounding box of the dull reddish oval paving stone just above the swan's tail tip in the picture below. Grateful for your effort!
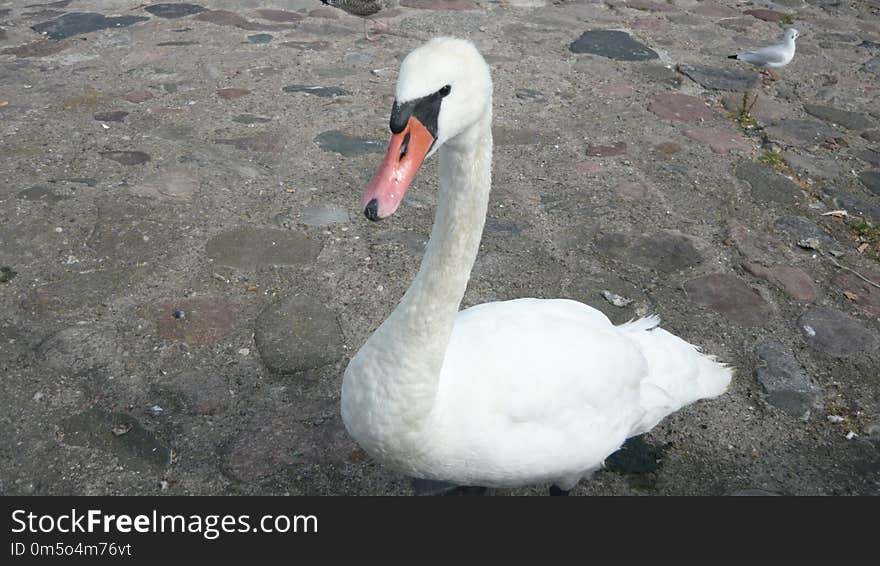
[684,273,770,326]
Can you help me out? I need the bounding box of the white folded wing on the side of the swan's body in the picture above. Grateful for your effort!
[432,299,648,485]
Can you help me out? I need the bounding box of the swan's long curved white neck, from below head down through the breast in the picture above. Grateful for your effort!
[342,105,492,460]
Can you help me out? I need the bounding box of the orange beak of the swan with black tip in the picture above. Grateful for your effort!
[361,117,434,221]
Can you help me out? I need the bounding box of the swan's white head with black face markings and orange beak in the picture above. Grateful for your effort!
[361,37,492,220]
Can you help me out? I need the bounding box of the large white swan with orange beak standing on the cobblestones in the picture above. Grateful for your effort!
[342,38,731,491]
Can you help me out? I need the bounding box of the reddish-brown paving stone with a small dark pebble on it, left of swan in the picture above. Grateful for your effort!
[138,297,240,344]
